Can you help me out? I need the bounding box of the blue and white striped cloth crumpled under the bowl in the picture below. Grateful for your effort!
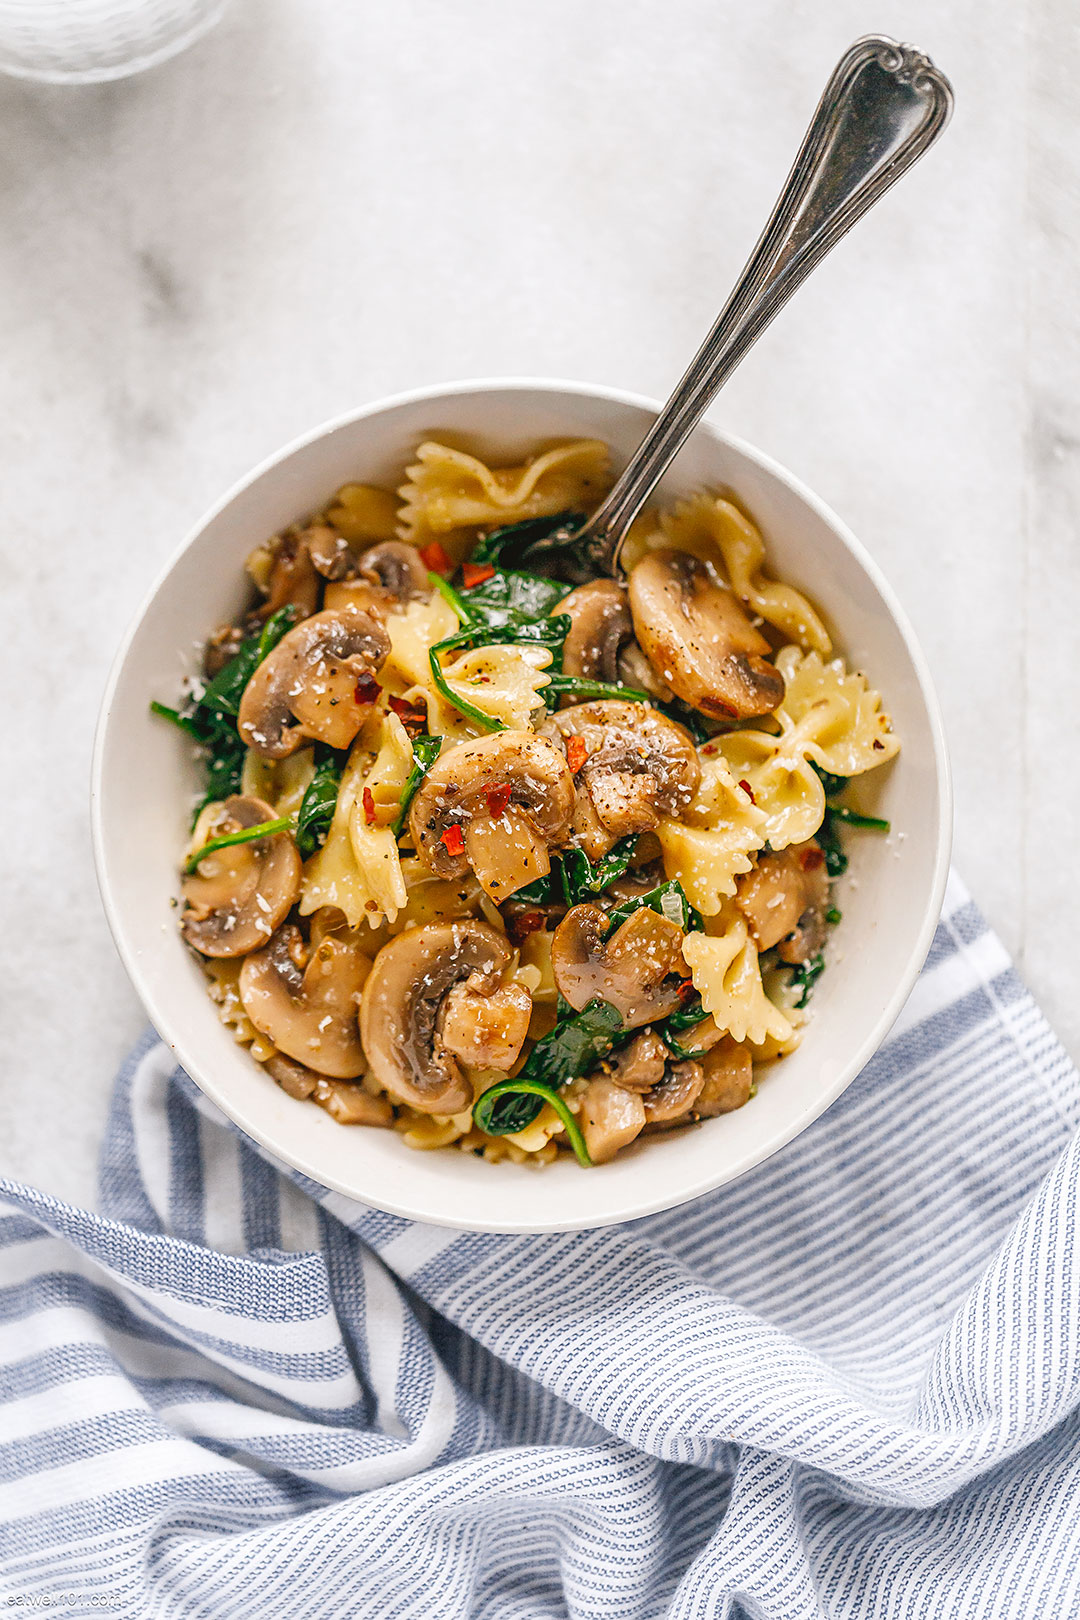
[0,886,1080,1620]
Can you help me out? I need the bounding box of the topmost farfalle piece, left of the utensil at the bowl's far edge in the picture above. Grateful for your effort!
[398,439,609,562]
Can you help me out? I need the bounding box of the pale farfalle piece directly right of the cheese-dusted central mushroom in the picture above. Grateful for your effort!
[657,753,766,917]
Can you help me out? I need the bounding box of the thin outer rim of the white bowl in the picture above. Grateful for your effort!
[89,376,954,1234]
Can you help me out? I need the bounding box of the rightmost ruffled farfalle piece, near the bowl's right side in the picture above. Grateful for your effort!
[776,646,900,776]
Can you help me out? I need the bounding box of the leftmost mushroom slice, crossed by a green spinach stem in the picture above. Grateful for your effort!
[180,794,301,956]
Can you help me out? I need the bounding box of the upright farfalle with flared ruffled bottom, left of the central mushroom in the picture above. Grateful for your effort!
[300,714,413,928]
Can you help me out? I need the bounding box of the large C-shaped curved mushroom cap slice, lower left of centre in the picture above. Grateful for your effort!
[359,920,528,1115]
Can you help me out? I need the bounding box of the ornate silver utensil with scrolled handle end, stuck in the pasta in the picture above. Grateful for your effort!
[573,36,952,573]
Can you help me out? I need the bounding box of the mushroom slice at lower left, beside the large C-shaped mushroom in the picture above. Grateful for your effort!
[240,923,371,1081]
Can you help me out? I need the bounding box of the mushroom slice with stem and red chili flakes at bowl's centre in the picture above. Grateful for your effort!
[408,731,573,902]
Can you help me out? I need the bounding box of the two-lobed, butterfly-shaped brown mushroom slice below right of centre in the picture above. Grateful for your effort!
[551,906,687,1029]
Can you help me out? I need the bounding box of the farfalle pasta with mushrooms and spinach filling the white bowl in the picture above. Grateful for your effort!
[155,439,899,1166]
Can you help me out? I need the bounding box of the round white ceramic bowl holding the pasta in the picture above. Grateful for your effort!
[92,381,952,1231]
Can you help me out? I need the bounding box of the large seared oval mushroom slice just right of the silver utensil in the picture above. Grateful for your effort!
[630,551,784,719]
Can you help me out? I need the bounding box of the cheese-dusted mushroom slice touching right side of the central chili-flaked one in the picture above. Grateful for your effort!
[552,698,701,860]
